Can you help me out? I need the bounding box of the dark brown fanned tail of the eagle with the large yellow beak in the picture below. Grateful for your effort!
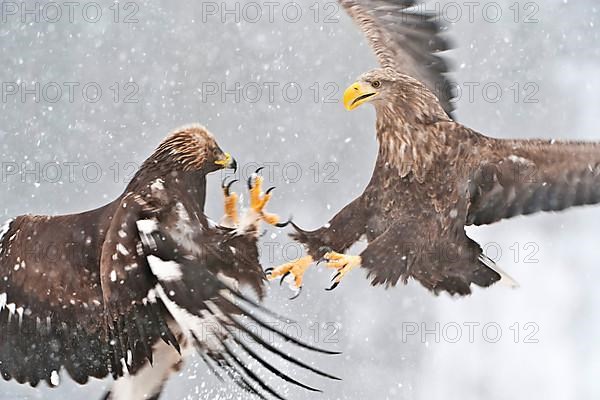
[361,220,502,295]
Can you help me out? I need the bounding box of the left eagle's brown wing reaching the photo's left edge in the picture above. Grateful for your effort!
[0,206,116,386]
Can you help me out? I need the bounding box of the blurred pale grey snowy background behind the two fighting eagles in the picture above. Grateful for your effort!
[0,0,600,400]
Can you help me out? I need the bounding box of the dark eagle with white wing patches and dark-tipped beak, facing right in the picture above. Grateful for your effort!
[0,126,335,400]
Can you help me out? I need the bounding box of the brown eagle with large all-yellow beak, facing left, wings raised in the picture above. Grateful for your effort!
[269,0,600,295]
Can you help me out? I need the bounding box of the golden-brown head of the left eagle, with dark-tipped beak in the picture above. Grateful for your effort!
[147,125,237,174]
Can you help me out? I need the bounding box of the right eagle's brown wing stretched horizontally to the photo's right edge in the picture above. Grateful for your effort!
[467,139,600,225]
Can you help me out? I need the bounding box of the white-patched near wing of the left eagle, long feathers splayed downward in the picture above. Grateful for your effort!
[101,195,333,398]
